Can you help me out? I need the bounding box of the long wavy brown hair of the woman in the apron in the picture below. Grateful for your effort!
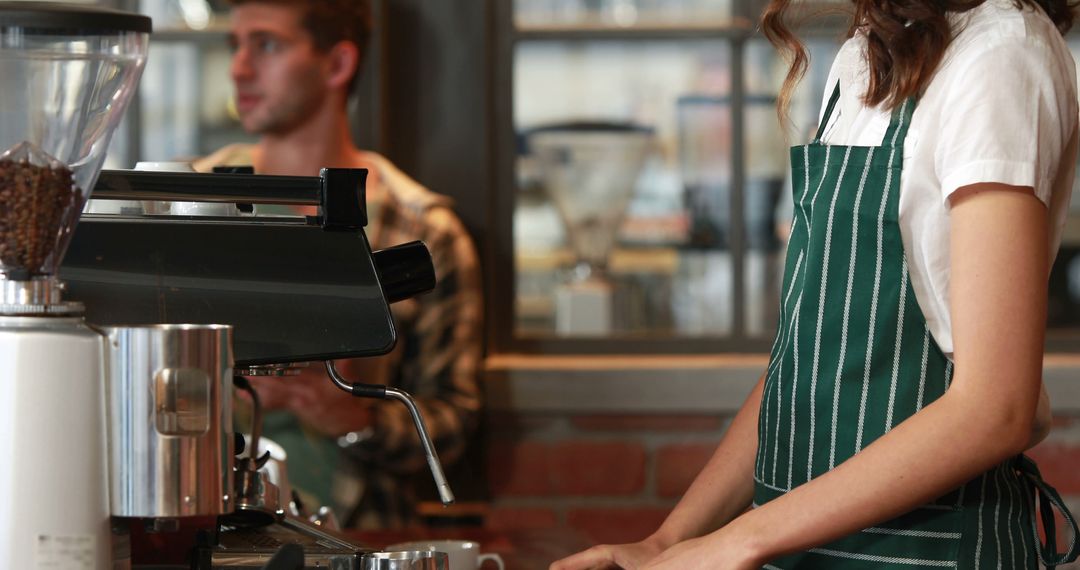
[761,0,1075,116]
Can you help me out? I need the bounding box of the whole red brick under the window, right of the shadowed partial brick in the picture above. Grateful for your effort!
[551,442,645,497]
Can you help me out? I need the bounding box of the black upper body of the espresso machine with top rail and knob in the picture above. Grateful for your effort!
[59,168,435,367]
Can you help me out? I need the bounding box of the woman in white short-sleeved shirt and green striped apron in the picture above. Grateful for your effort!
[552,0,1078,570]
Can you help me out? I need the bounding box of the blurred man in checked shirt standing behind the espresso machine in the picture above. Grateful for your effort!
[194,0,483,528]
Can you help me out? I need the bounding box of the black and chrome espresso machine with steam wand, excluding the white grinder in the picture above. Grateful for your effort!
[59,168,454,570]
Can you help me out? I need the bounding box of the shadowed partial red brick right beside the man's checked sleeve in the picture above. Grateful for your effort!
[487,442,552,497]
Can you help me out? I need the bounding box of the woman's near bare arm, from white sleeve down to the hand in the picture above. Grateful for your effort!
[649,184,1048,569]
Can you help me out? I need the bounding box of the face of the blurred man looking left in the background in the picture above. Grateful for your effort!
[229,2,327,135]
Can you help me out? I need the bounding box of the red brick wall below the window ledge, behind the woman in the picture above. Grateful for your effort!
[485,411,1080,570]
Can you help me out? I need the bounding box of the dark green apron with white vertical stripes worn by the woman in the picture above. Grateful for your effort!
[754,86,1077,570]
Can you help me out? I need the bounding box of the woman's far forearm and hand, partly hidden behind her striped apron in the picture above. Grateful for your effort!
[551,376,765,570]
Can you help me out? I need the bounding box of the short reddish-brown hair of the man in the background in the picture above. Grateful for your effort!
[228,0,372,65]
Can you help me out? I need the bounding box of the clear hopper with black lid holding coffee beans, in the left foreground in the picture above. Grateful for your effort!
[0,1,150,281]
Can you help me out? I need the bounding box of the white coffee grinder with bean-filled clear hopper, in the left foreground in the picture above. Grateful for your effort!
[0,2,150,569]
